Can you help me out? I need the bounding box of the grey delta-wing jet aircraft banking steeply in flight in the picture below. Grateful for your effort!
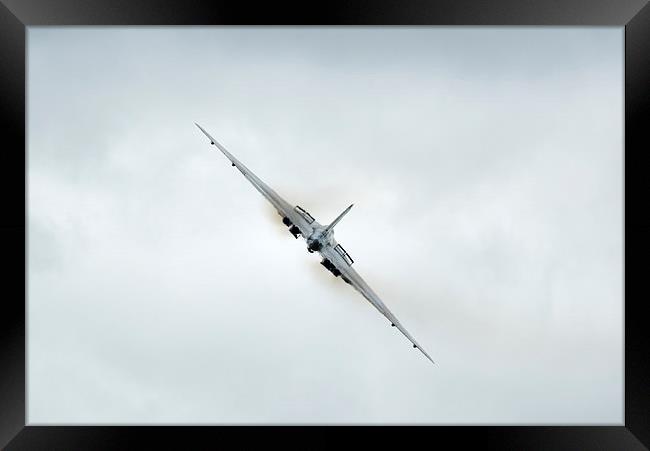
[195,124,433,363]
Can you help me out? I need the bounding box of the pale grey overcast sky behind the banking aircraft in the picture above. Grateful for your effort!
[27,27,623,424]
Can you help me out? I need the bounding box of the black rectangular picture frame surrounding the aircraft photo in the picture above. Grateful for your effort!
[0,0,650,450]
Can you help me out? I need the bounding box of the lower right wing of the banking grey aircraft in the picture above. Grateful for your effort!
[320,240,435,363]
